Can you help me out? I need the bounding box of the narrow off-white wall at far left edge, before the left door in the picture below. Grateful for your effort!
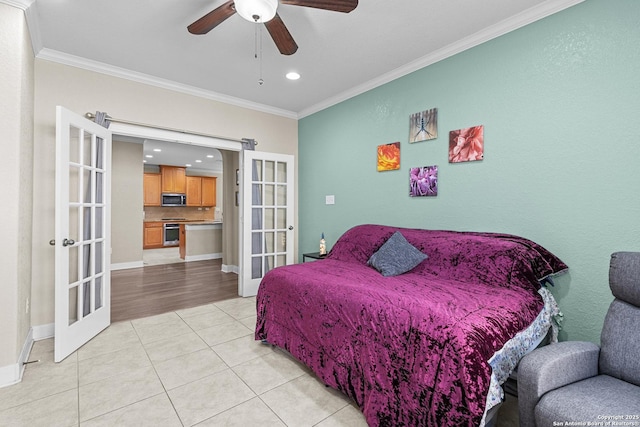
[0,3,34,374]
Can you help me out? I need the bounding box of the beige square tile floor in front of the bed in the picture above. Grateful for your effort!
[0,298,517,427]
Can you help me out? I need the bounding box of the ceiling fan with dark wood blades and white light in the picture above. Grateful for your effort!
[187,0,358,55]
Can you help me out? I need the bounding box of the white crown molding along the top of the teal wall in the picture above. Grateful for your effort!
[298,0,584,119]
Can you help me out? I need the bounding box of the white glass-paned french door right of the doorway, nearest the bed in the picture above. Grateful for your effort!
[239,150,295,297]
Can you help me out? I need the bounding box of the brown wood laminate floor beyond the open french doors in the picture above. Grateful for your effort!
[111,259,238,322]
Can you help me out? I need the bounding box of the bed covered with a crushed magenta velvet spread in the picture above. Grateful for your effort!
[255,224,567,426]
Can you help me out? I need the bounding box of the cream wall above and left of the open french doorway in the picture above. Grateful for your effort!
[31,59,298,325]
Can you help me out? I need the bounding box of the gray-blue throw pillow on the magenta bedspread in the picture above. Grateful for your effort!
[367,231,428,277]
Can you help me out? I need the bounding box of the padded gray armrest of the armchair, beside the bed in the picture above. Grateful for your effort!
[518,341,600,427]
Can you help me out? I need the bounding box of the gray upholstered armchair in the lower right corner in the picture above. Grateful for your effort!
[518,252,640,427]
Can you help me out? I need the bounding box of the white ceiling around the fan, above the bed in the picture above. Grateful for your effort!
[27,0,582,118]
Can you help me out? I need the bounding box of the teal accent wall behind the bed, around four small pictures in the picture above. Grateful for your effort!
[298,0,640,343]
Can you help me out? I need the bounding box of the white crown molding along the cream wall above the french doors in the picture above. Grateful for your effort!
[36,48,298,119]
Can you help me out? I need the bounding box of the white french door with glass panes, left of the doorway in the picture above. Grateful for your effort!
[51,106,111,362]
